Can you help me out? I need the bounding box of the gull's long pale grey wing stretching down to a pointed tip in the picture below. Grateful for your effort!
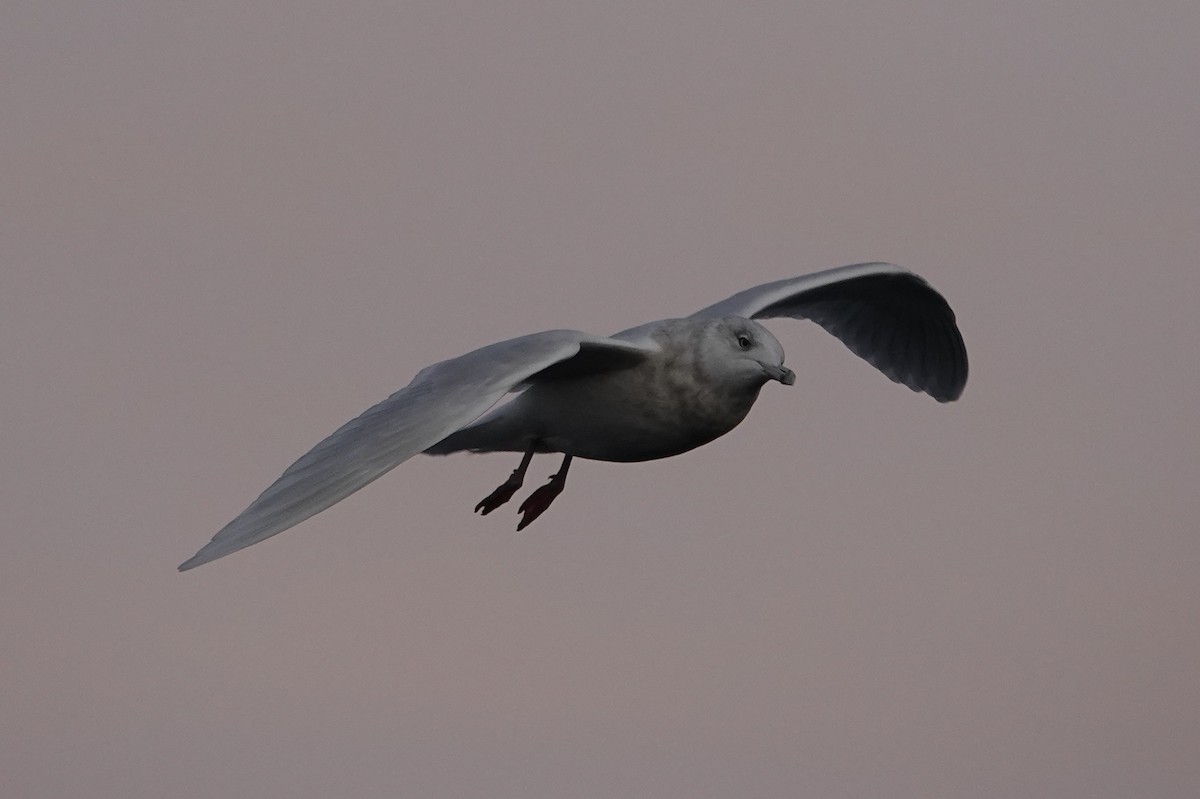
[179,330,653,571]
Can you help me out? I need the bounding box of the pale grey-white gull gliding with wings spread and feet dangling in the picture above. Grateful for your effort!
[179,263,967,571]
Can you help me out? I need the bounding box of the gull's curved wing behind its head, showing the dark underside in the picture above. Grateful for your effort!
[692,264,967,402]
